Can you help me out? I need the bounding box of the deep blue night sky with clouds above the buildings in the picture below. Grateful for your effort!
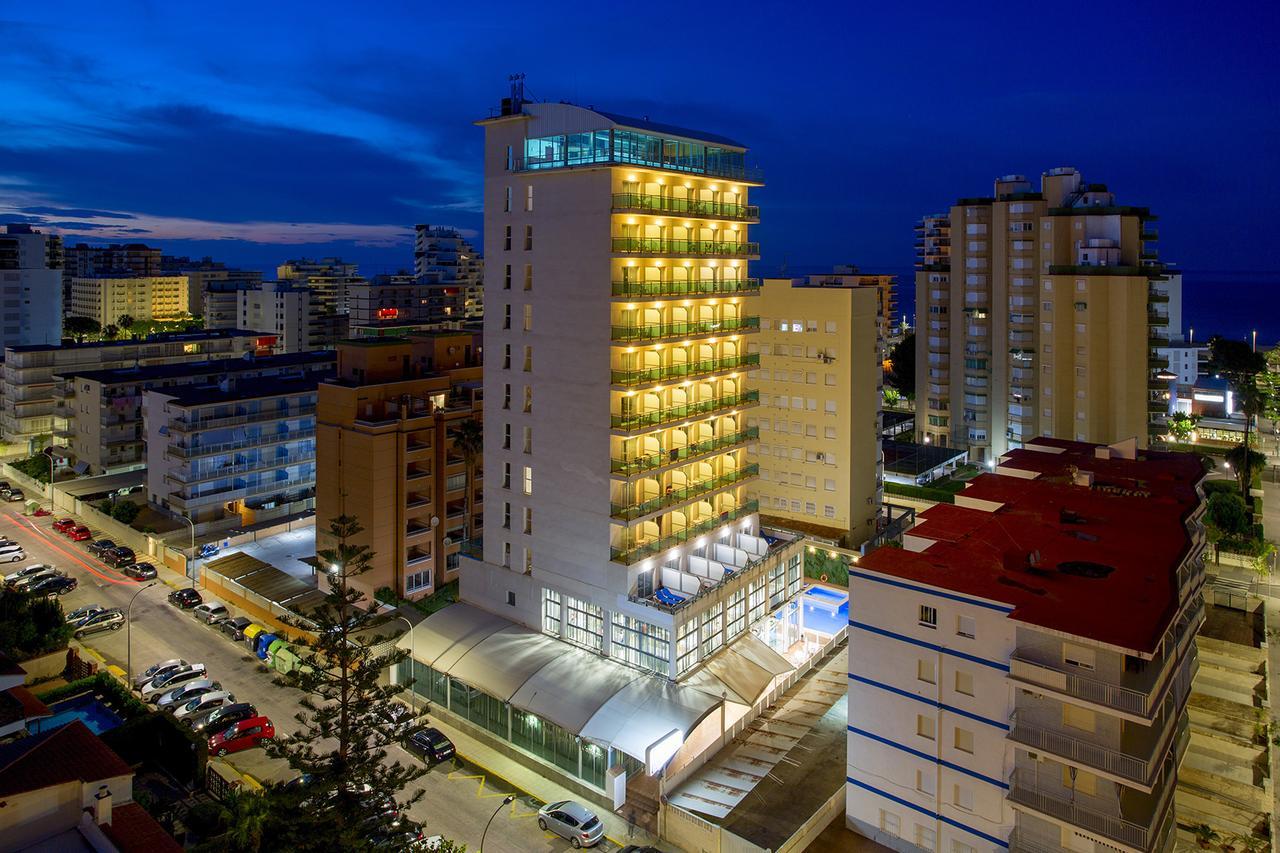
[0,0,1280,337]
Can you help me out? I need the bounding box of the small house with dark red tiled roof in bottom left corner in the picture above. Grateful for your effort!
[0,720,182,853]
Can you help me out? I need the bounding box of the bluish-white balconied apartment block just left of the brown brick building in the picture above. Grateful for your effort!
[142,377,319,533]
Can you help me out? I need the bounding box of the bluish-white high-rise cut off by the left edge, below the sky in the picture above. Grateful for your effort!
[0,225,63,347]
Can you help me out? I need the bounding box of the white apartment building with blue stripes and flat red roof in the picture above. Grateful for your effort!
[846,438,1206,853]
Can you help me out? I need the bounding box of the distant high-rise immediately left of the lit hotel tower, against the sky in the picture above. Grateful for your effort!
[413,224,484,323]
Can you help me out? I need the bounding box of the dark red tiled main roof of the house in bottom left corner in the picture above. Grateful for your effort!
[0,720,133,797]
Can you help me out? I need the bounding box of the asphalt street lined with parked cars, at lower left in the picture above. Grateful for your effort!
[0,506,612,853]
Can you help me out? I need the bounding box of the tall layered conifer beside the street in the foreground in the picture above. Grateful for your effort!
[266,515,426,850]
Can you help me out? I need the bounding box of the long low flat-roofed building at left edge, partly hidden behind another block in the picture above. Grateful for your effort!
[0,329,275,442]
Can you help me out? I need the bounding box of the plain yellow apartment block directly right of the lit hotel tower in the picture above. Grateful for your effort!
[746,275,883,548]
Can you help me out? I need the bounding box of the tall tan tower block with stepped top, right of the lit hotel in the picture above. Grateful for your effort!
[916,168,1171,464]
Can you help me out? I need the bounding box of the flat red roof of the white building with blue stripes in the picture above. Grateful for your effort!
[859,442,1204,653]
